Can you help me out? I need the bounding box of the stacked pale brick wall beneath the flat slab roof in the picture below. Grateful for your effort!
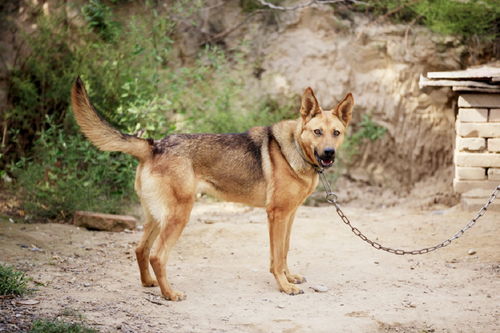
[453,94,500,208]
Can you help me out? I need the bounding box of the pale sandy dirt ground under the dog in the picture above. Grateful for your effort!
[0,191,500,333]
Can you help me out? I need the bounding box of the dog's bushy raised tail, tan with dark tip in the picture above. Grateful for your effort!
[71,78,151,160]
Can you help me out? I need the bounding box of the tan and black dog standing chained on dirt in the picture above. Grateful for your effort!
[71,78,354,301]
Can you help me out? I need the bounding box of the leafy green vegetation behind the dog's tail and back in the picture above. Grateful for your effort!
[2,0,289,219]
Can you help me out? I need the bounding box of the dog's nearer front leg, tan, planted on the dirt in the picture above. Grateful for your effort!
[267,207,304,295]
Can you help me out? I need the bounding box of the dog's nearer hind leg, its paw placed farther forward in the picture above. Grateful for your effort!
[150,182,195,301]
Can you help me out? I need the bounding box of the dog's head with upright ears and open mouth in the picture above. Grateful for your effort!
[299,88,354,168]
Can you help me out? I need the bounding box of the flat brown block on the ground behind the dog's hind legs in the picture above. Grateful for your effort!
[73,211,137,231]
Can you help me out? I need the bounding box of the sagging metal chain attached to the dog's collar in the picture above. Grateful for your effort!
[318,170,500,255]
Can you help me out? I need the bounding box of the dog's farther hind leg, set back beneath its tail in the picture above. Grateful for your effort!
[135,206,160,287]
